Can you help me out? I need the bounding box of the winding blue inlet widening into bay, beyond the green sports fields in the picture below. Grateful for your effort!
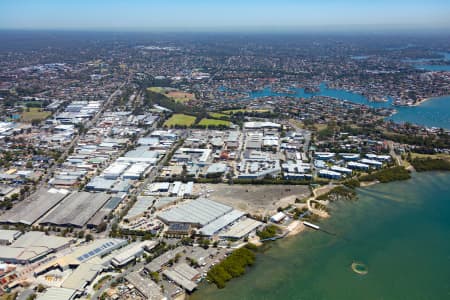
[249,83,450,129]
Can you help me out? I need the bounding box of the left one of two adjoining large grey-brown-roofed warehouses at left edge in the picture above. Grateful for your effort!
[0,188,69,225]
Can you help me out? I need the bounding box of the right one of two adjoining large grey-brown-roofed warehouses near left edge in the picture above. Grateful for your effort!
[40,192,111,228]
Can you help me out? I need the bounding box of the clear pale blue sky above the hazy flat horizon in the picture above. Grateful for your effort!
[0,0,450,31]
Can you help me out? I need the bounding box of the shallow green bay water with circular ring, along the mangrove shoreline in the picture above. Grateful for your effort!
[192,172,450,300]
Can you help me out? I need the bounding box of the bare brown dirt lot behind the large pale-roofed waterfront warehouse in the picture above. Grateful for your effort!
[195,184,311,215]
